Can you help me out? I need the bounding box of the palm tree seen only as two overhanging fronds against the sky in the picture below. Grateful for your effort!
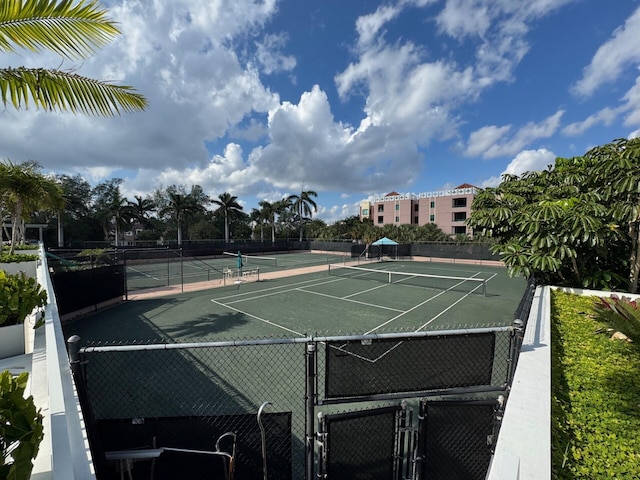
[0,0,147,117]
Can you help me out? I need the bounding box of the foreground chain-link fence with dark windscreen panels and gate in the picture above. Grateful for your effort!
[69,316,536,480]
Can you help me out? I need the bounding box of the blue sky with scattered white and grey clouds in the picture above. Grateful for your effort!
[0,0,640,223]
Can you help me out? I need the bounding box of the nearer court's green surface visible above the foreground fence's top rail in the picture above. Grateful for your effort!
[65,254,526,345]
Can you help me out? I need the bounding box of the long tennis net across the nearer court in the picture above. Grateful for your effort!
[329,264,487,296]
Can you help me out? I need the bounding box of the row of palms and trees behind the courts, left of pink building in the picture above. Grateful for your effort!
[0,161,317,249]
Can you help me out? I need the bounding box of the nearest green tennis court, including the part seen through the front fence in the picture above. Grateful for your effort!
[64,254,526,479]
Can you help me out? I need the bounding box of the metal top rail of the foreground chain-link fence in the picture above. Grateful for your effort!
[80,326,514,353]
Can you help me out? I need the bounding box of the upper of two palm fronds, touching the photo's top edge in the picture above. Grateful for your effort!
[0,0,120,58]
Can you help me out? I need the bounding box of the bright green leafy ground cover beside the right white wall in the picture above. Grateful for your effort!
[551,291,640,479]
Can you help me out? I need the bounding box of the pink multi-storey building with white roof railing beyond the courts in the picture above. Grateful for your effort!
[360,183,477,236]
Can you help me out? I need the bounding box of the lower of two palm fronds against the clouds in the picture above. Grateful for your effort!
[0,67,147,117]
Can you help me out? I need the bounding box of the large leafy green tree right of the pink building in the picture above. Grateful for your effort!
[469,140,640,292]
